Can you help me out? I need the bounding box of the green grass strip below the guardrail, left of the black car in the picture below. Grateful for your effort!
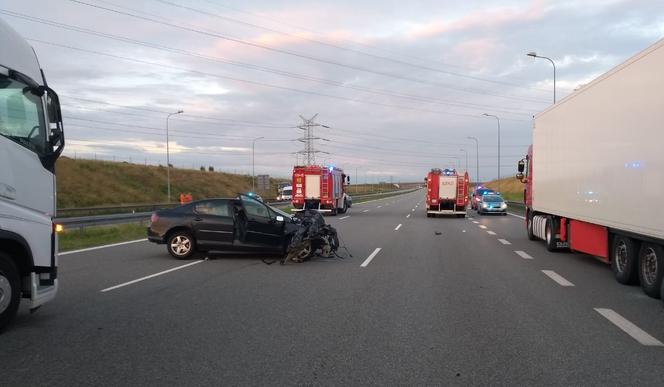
[58,223,146,251]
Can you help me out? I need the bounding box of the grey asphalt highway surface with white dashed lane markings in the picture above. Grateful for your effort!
[0,191,664,386]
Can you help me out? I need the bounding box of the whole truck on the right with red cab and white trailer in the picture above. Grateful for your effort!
[517,40,664,297]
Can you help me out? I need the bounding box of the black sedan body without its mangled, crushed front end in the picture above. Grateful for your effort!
[148,195,298,259]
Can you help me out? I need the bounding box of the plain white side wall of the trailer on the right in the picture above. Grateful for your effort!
[532,39,664,239]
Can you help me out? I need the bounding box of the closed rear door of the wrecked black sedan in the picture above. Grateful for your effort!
[192,200,235,247]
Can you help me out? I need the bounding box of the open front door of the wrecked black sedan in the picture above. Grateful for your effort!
[240,195,284,247]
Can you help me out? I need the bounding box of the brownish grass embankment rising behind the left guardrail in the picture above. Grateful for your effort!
[56,157,288,208]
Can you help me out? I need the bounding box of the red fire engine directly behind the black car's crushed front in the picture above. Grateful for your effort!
[291,165,350,215]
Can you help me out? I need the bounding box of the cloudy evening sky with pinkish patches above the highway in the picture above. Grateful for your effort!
[0,0,664,183]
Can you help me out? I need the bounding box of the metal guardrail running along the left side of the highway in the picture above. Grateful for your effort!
[55,189,415,228]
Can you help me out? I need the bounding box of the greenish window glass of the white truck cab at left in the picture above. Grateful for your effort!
[0,74,46,155]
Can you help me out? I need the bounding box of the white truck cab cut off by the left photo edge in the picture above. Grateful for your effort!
[0,20,64,330]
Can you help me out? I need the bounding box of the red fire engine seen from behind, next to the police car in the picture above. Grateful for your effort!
[424,168,469,218]
